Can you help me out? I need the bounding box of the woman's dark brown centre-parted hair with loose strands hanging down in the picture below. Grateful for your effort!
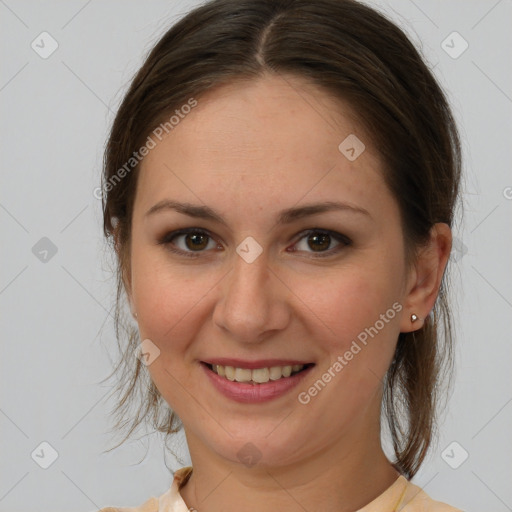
[103,0,461,478]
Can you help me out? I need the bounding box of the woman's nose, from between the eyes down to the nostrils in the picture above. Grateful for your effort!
[213,248,291,343]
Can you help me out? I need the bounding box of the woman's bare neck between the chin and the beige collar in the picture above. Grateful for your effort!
[180,418,399,512]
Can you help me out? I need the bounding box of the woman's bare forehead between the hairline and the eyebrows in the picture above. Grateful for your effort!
[137,76,394,224]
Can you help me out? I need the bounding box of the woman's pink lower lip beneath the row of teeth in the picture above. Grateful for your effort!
[201,363,314,404]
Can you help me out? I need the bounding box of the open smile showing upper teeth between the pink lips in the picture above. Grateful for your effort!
[201,361,314,385]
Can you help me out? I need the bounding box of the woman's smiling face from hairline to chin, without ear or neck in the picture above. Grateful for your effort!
[129,77,407,465]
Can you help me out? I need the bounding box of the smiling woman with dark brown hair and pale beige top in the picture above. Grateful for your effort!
[98,0,460,512]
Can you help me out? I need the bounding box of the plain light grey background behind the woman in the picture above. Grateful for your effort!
[0,0,512,512]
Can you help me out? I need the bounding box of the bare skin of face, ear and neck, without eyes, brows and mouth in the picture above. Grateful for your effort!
[125,75,451,512]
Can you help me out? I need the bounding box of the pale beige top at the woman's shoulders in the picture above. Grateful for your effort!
[99,466,462,512]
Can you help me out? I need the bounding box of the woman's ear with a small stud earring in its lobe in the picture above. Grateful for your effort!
[400,222,452,332]
